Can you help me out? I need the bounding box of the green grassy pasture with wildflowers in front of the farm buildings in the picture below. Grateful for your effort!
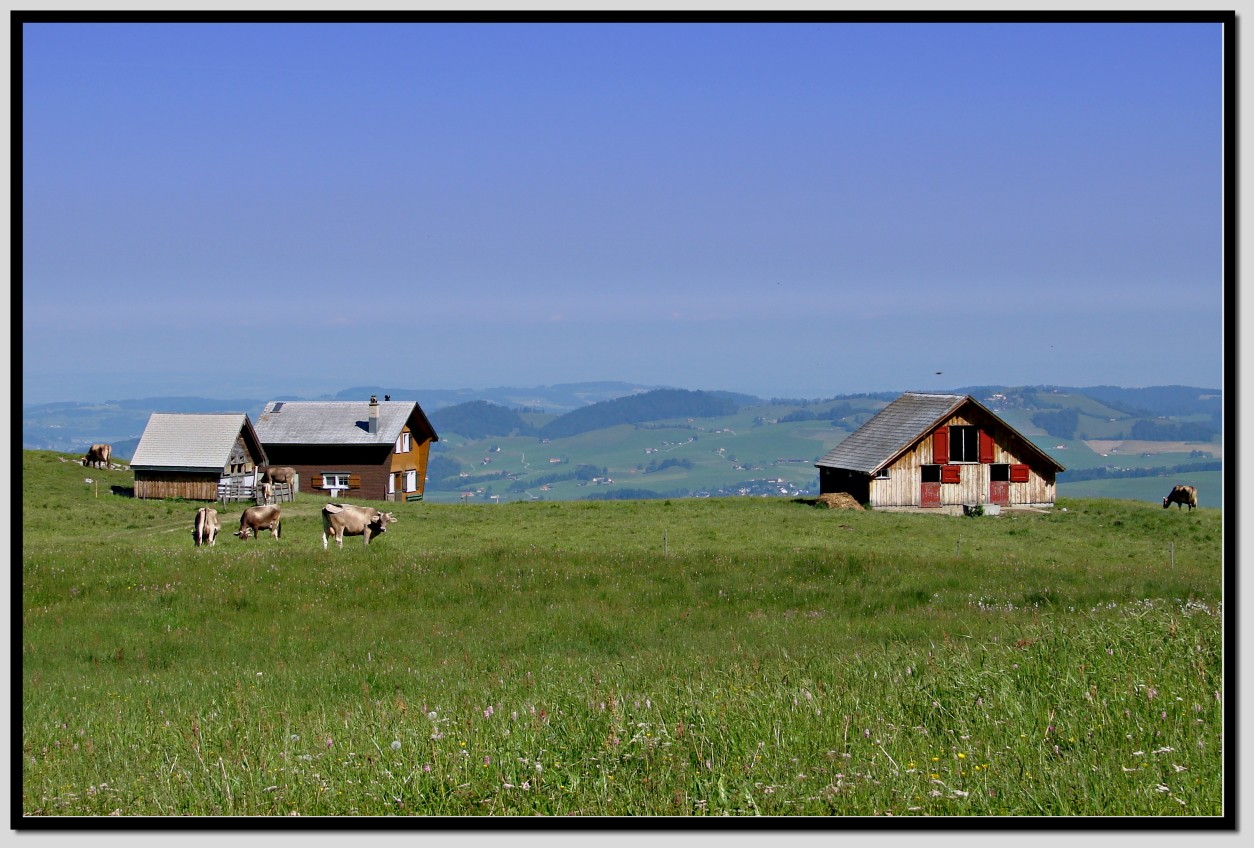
[19,452,1230,827]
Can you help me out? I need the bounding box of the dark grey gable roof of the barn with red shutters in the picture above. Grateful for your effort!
[815,391,1063,474]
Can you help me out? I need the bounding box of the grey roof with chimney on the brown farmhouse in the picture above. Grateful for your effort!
[257,400,440,445]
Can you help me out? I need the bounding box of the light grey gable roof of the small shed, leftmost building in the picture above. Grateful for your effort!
[130,413,266,472]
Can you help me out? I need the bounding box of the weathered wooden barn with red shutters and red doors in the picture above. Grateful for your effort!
[815,391,1066,512]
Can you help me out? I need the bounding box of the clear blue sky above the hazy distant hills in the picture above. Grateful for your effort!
[20,23,1224,403]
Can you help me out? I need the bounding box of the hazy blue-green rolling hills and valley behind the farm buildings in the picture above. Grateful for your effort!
[23,383,1223,507]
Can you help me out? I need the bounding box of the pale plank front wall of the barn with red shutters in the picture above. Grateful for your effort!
[868,410,1056,507]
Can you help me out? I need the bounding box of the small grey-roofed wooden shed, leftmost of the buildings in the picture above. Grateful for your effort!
[130,413,266,501]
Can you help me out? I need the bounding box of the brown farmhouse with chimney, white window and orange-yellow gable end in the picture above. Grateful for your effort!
[257,396,439,501]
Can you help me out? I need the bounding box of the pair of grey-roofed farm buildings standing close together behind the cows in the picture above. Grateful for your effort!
[130,396,439,502]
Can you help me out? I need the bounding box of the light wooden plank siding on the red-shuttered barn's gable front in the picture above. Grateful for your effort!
[867,408,1056,508]
